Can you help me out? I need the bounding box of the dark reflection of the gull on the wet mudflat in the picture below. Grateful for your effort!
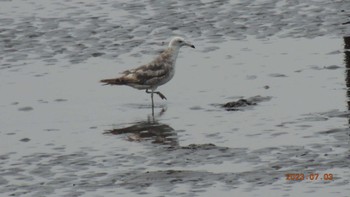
[104,108,178,147]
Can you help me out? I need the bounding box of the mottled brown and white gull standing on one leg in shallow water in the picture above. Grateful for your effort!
[100,37,195,113]
